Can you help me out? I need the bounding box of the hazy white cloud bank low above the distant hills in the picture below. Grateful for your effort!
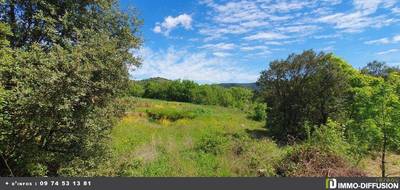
[131,48,258,83]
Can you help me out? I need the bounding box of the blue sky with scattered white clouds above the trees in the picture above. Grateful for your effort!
[119,0,400,83]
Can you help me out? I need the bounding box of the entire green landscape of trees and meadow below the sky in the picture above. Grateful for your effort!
[0,0,400,177]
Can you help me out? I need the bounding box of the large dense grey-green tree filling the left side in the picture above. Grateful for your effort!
[0,0,141,176]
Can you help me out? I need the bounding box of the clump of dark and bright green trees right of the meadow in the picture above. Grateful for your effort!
[258,50,400,177]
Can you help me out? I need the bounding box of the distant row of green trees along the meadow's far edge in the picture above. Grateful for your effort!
[129,79,253,110]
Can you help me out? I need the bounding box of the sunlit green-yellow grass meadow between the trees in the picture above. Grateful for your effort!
[102,98,283,176]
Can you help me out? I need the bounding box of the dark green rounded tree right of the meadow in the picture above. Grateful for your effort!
[257,50,350,143]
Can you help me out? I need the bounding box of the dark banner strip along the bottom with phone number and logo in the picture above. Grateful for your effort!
[0,177,400,190]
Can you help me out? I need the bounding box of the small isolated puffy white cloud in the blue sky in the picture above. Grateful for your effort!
[153,14,192,36]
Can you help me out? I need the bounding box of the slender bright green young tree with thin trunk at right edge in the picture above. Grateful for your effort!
[346,72,400,177]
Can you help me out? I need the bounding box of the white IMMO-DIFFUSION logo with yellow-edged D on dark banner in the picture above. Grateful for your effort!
[325,178,400,190]
